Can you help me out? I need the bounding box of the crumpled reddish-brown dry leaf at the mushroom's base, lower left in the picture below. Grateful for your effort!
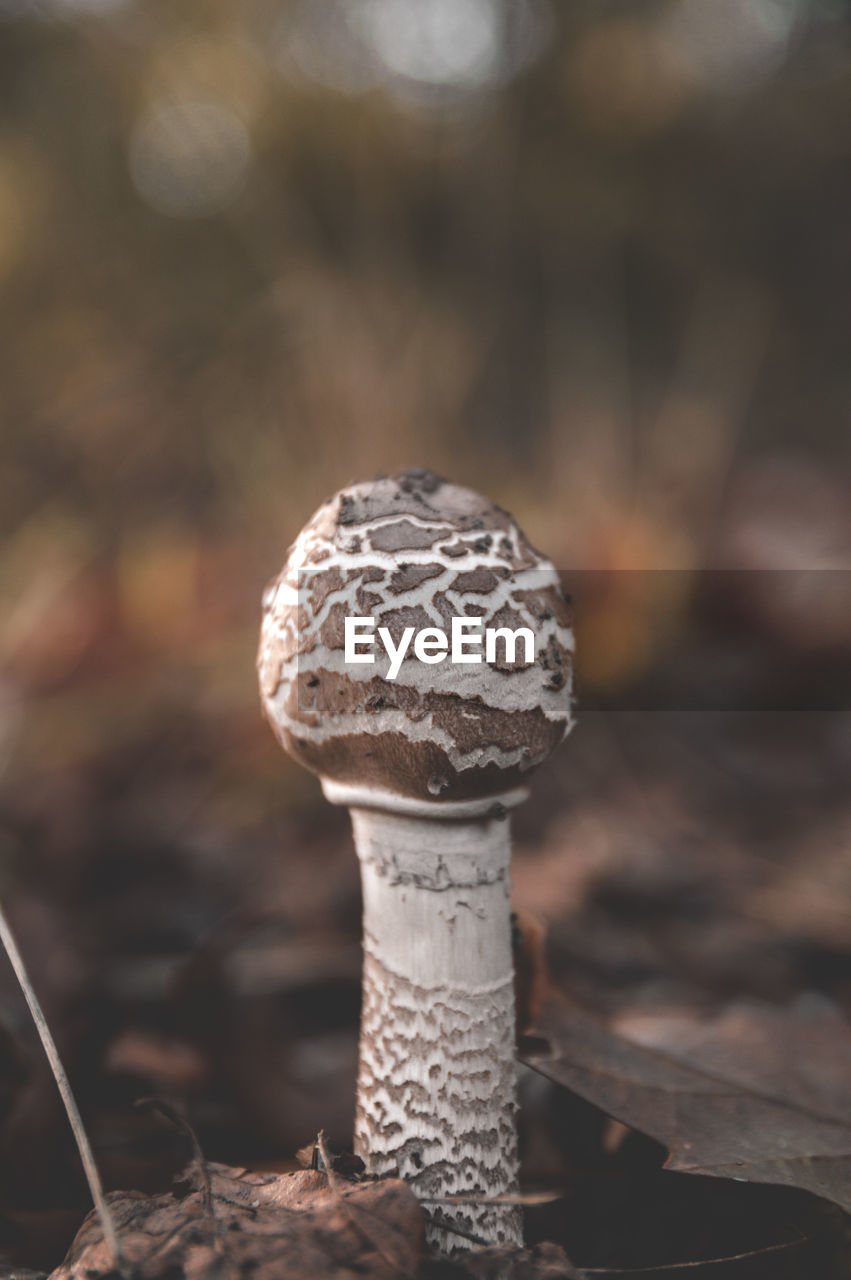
[50,1165,422,1280]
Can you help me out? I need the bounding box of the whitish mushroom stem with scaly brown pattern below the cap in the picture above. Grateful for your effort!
[322,781,526,1253]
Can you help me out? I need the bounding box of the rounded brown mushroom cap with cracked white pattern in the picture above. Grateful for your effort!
[257,470,573,800]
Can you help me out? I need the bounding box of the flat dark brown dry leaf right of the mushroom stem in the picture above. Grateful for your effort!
[521,1001,851,1211]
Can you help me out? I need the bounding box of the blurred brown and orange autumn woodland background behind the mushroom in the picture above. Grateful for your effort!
[0,0,851,1265]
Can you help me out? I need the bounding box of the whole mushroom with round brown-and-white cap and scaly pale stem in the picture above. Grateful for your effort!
[257,470,573,1253]
